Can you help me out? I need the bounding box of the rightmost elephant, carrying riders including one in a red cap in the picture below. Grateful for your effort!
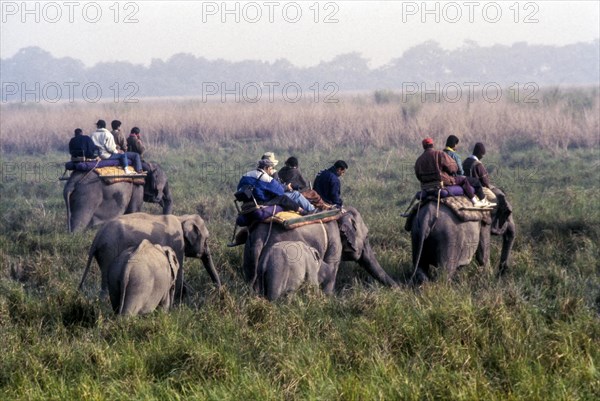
[409,188,516,284]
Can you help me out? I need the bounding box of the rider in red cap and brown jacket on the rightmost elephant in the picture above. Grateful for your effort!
[415,138,489,207]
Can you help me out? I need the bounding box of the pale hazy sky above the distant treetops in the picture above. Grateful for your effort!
[0,0,600,67]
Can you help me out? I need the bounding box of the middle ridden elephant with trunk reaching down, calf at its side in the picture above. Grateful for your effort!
[243,207,398,294]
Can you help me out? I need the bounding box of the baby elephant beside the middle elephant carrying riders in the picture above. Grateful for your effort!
[258,241,321,301]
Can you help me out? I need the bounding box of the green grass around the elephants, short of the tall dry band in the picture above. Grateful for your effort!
[0,111,600,400]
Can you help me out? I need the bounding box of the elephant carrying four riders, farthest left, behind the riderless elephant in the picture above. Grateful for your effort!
[63,163,173,232]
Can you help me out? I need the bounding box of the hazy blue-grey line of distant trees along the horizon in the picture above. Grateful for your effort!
[0,40,600,102]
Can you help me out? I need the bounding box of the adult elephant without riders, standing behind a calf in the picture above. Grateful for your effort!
[79,213,221,297]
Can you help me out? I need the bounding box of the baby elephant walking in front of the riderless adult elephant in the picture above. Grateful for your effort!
[108,240,179,315]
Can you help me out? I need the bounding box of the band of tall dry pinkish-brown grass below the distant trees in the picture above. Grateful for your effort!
[0,89,600,154]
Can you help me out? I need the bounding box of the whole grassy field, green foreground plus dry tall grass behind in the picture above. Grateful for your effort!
[0,90,600,401]
